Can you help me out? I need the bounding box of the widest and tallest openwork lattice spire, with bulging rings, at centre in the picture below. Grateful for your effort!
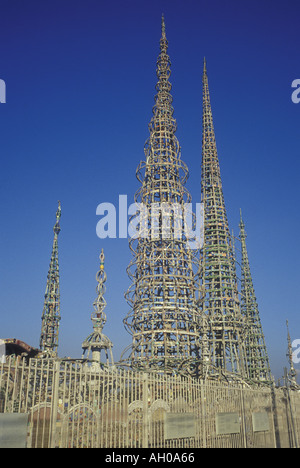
[124,17,199,372]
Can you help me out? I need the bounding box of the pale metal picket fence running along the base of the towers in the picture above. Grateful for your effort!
[0,357,300,448]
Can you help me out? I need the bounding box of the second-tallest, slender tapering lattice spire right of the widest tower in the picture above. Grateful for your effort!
[200,61,247,377]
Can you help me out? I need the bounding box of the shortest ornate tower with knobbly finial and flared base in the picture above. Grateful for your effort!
[82,249,114,371]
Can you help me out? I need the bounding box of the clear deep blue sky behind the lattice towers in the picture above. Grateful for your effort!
[0,0,300,377]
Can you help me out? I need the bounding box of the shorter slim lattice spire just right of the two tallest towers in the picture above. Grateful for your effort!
[240,212,272,383]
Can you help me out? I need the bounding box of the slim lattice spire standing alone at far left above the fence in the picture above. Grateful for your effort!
[40,202,61,357]
